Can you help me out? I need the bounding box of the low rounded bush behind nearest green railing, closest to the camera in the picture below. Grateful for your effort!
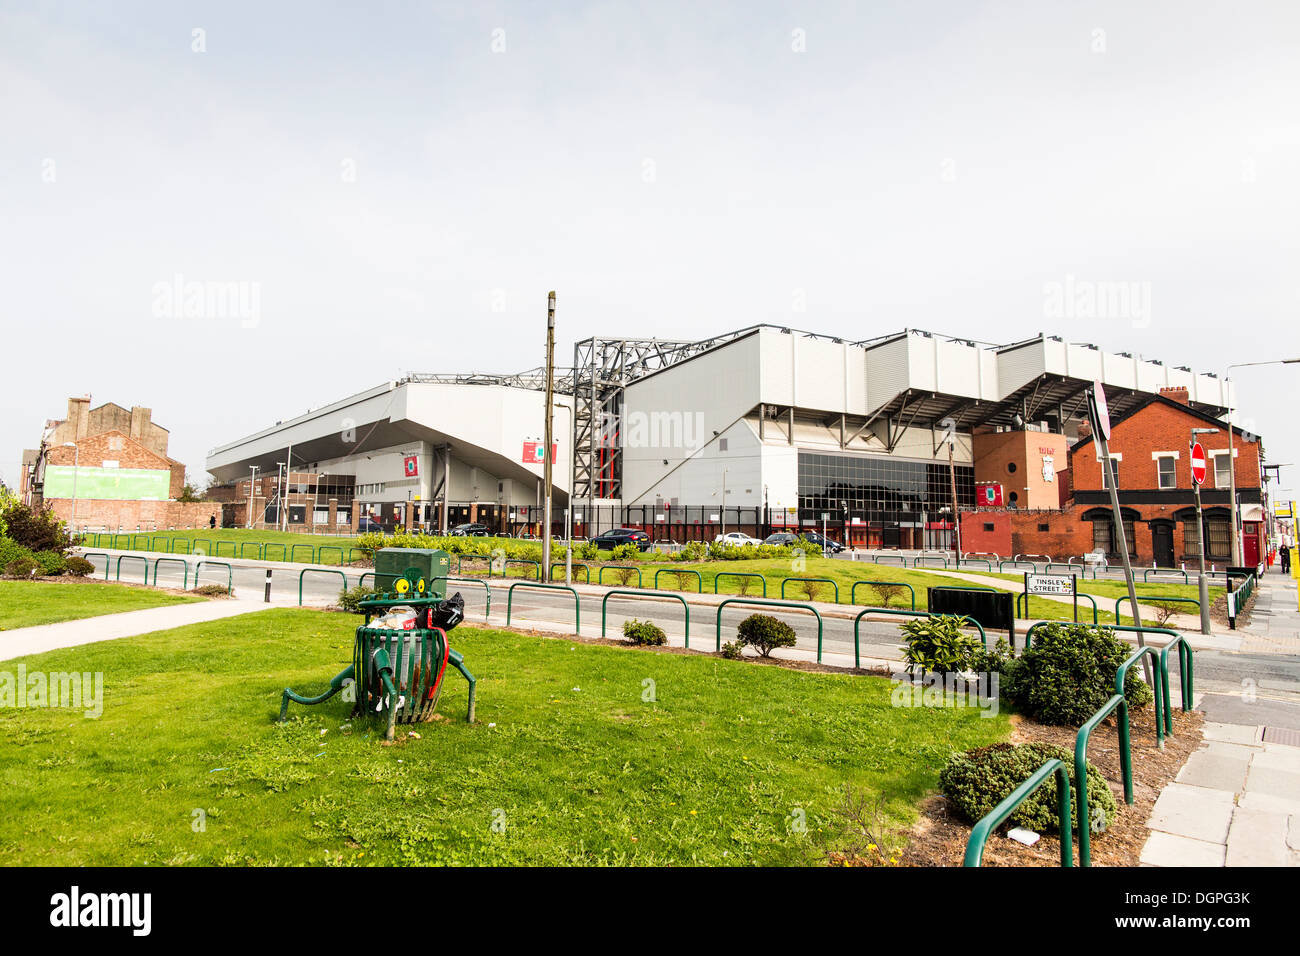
[939,743,1119,834]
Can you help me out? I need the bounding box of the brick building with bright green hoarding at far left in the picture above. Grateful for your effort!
[20,397,220,531]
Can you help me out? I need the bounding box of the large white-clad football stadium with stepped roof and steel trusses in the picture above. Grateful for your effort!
[207,325,1231,533]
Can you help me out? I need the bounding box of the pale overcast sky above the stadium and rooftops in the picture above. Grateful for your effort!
[0,0,1300,497]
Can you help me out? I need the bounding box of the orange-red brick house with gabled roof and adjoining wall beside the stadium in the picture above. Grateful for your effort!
[962,389,1265,567]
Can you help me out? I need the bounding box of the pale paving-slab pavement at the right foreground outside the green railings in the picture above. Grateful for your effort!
[1141,568,1300,866]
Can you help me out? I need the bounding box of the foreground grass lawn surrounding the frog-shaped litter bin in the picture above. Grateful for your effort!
[0,609,1009,865]
